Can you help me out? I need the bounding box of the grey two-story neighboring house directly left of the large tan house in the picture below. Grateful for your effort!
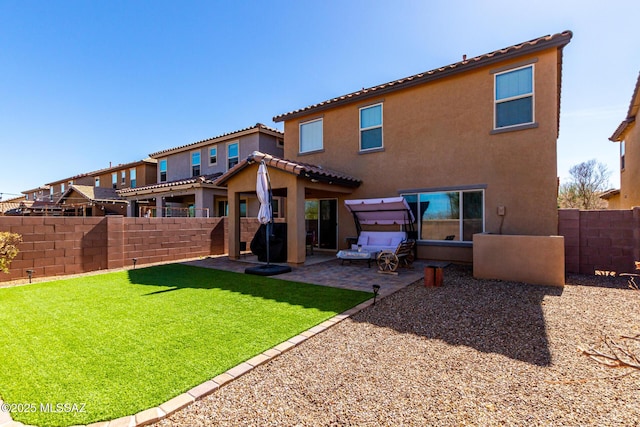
[118,123,284,217]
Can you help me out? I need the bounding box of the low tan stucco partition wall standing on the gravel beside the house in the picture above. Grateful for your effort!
[473,234,565,286]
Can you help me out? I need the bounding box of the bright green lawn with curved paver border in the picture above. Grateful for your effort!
[0,264,371,426]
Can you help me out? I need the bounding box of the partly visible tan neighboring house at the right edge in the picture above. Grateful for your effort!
[602,74,640,209]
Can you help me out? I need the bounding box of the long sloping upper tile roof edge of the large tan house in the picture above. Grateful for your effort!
[273,31,573,122]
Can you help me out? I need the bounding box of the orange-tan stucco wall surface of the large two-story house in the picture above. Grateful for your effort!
[285,48,559,261]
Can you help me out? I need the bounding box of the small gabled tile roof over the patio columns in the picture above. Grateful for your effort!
[216,151,362,187]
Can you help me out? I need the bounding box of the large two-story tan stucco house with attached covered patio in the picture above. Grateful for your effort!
[217,31,572,263]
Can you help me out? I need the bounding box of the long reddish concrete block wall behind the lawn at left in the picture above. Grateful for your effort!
[0,216,229,282]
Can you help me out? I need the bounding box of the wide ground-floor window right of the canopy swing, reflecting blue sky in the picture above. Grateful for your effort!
[403,189,484,242]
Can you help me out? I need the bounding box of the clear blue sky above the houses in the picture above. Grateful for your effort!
[0,0,640,199]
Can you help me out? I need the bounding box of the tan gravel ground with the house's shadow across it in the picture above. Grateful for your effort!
[157,266,640,426]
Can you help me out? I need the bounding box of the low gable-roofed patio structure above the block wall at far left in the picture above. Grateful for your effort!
[56,184,128,216]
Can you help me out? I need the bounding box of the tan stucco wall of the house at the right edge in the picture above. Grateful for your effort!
[618,122,640,209]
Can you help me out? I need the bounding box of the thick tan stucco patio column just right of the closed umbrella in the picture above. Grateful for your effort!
[287,180,306,264]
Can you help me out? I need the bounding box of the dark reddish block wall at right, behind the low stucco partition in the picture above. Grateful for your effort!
[558,207,640,274]
